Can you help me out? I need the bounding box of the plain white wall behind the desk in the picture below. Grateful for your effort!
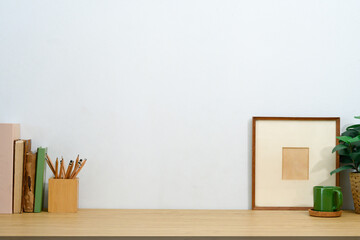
[0,0,360,209]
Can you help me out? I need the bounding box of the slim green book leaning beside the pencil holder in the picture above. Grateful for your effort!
[34,147,46,212]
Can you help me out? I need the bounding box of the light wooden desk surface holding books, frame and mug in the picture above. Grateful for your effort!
[0,209,360,236]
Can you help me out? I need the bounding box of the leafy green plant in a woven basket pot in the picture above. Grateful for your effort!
[330,116,360,213]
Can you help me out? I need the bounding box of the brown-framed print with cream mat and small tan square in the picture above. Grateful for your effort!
[252,117,340,210]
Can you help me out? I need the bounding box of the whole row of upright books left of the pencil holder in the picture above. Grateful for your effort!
[0,124,46,213]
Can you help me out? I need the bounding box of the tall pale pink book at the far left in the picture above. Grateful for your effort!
[0,123,20,213]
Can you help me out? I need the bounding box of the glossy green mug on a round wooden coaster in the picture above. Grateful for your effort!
[314,186,343,212]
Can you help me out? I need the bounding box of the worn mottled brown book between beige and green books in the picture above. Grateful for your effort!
[23,152,36,212]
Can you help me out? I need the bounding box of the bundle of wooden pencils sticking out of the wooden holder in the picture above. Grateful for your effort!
[46,154,87,179]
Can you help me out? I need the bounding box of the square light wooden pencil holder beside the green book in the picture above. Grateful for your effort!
[48,178,79,213]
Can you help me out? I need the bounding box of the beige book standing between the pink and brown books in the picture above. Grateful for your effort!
[13,140,25,213]
